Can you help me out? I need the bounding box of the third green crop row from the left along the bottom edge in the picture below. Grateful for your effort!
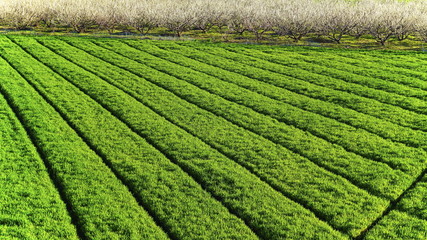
[3,35,266,239]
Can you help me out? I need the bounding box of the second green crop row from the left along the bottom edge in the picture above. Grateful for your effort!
[0,39,167,239]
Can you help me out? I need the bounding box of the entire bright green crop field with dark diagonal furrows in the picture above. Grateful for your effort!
[0,35,427,240]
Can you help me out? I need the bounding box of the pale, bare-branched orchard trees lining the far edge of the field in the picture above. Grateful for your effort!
[0,0,427,45]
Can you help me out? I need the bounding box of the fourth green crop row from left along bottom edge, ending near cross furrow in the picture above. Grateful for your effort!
[7,35,352,239]
